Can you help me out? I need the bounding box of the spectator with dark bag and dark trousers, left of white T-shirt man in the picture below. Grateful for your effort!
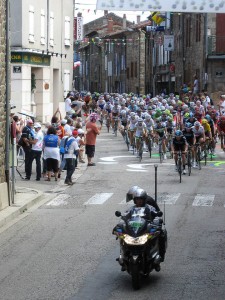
[19,119,34,180]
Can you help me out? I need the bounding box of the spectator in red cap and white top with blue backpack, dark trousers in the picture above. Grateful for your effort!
[64,130,79,185]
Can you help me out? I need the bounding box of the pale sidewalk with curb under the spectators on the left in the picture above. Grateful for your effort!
[0,163,87,229]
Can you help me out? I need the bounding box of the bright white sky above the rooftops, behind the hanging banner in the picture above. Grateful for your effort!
[75,0,150,24]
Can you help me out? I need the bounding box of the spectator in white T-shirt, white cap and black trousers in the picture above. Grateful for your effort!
[29,123,44,181]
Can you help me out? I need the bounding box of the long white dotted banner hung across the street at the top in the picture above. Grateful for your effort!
[96,0,225,13]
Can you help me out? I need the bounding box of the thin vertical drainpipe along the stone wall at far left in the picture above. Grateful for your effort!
[5,0,11,205]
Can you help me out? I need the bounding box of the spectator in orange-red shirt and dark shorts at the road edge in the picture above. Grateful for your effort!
[85,113,102,166]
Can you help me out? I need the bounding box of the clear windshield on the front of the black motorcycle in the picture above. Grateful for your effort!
[128,207,146,235]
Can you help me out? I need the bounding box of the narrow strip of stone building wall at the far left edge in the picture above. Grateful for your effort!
[0,0,8,210]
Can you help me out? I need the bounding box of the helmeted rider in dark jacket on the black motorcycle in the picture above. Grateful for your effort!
[116,186,167,271]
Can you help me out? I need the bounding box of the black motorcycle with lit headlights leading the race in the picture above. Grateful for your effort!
[112,207,167,290]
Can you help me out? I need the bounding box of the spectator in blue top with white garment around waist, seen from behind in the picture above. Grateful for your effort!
[43,126,60,181]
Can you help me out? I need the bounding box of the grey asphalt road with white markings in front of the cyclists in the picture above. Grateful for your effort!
[0,127,225,300]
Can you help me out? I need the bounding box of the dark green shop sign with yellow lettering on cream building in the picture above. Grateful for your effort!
[11,52,50,66]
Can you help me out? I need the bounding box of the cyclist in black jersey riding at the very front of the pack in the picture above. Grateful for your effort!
[172,130,188,175]
